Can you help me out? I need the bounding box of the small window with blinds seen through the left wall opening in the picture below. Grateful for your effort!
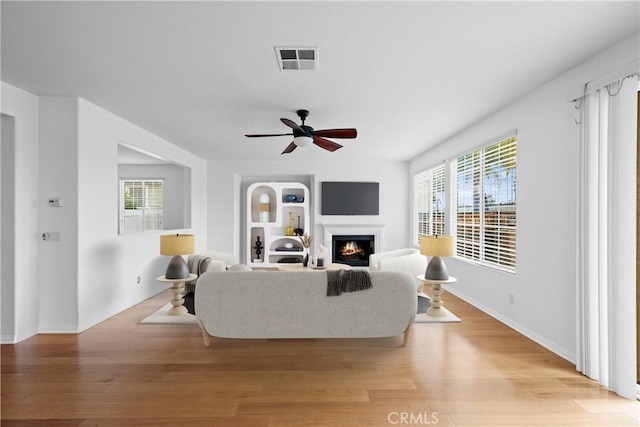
[120,179,164,234]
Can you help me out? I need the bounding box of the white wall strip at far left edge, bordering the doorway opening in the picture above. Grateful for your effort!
[0,82,39,342]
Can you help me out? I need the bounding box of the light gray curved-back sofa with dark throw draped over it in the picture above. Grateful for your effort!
[195,270,417,345]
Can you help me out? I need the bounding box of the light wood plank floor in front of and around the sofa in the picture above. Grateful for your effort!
[1,292,640,426]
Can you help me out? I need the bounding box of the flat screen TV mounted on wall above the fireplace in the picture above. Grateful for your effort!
[320,181,380,215]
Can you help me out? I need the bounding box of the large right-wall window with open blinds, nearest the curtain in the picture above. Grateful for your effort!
[456,136,517,271]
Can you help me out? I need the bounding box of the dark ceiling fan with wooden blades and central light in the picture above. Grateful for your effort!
[245,110,358,154]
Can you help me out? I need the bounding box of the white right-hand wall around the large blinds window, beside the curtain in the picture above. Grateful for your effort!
[410,34,639,361]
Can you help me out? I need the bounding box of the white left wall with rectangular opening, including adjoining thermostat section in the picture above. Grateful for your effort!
[33,97,206,332]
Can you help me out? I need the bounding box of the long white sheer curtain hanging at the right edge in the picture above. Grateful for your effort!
[575,72,638,399]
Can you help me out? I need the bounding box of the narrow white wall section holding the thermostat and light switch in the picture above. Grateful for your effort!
[38,97,78,332]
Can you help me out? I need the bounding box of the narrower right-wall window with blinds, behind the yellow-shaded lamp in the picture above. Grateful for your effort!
[414,164,445,245]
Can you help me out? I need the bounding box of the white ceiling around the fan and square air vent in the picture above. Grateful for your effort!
[1,0,639,161]
